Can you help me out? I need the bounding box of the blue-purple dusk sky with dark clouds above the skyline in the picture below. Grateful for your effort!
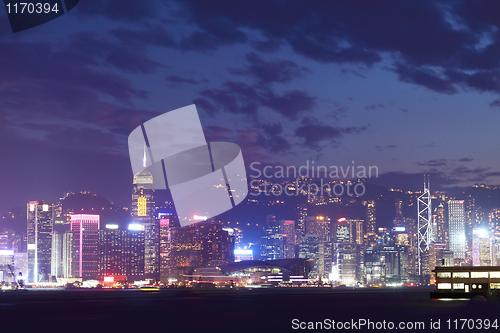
[0,0,500,214]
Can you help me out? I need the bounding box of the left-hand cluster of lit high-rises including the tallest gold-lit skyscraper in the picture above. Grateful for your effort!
[0,170,235,283]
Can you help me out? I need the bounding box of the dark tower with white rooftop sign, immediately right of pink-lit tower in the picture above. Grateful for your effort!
[98,224,125,279]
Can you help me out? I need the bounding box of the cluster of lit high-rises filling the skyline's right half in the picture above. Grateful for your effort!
[260,194,500,286]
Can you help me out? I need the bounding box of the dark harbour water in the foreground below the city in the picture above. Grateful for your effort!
[0,288,500,333]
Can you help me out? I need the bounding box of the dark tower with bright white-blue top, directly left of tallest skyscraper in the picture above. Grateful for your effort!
[122,223,146,280]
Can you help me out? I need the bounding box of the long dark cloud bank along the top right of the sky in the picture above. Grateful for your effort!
[172,0,500,94]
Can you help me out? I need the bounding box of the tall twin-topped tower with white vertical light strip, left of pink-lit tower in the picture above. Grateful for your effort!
[27,201,53,282]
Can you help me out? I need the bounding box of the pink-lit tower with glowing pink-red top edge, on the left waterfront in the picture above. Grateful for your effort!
[71,214,99,280]
